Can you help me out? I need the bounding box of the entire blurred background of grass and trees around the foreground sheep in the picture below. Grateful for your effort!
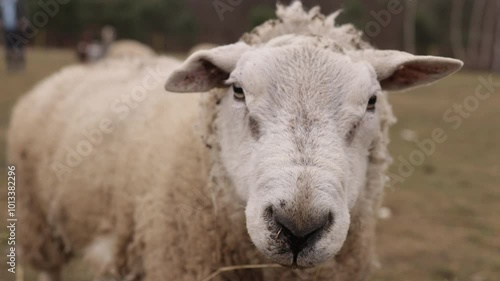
[0,0,500,281]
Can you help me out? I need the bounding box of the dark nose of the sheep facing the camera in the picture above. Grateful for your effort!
[272,208,333,256]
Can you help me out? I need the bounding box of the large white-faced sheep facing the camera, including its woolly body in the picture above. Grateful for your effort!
[8,1,462,281]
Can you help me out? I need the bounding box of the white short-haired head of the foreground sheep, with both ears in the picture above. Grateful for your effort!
[166,37,462,267]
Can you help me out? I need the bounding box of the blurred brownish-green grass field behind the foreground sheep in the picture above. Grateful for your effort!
[0,47,500,281]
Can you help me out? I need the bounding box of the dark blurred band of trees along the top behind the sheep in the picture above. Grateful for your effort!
[16,0,500,68]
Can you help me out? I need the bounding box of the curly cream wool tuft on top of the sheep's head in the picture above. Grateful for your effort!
[241,1,372,50]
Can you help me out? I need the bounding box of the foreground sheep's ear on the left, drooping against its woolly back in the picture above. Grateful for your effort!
[165,43,250,93]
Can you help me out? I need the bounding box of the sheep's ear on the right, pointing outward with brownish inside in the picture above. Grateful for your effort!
[352,50,463,90]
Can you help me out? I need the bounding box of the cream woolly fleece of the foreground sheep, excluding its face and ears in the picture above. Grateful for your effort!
[8,2,460,281]
